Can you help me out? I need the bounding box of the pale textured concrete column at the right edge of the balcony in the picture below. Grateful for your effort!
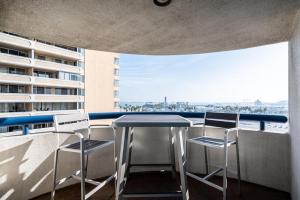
[289,12,300,200]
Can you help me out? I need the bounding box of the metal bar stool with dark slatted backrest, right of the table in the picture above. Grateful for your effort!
[186,112,241,200]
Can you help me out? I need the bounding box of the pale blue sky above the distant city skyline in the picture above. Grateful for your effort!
[119,42,288,103]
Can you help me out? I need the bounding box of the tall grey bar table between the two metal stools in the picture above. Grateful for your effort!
[112,114,193,200]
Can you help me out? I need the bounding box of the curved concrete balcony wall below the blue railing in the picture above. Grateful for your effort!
[0,127,290,200]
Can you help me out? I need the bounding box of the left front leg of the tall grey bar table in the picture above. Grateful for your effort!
[116,127,129,200]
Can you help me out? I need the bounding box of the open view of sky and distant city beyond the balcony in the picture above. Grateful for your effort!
[119,43,288,133]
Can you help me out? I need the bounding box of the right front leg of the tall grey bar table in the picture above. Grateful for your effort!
[173,128,189,200]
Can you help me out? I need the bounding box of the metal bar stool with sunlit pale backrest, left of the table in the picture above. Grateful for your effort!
[51,113,116,200]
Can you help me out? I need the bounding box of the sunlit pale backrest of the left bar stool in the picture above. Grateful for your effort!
[54,113,90,132]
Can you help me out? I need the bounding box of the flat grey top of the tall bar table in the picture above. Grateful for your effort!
[113,114,193,127]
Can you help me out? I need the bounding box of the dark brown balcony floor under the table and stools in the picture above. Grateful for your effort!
[35,172,290,200]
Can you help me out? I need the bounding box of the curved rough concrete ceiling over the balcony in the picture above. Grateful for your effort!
[0,0,299,55]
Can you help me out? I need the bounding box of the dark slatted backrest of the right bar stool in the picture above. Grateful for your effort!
[204,112,239,129]
